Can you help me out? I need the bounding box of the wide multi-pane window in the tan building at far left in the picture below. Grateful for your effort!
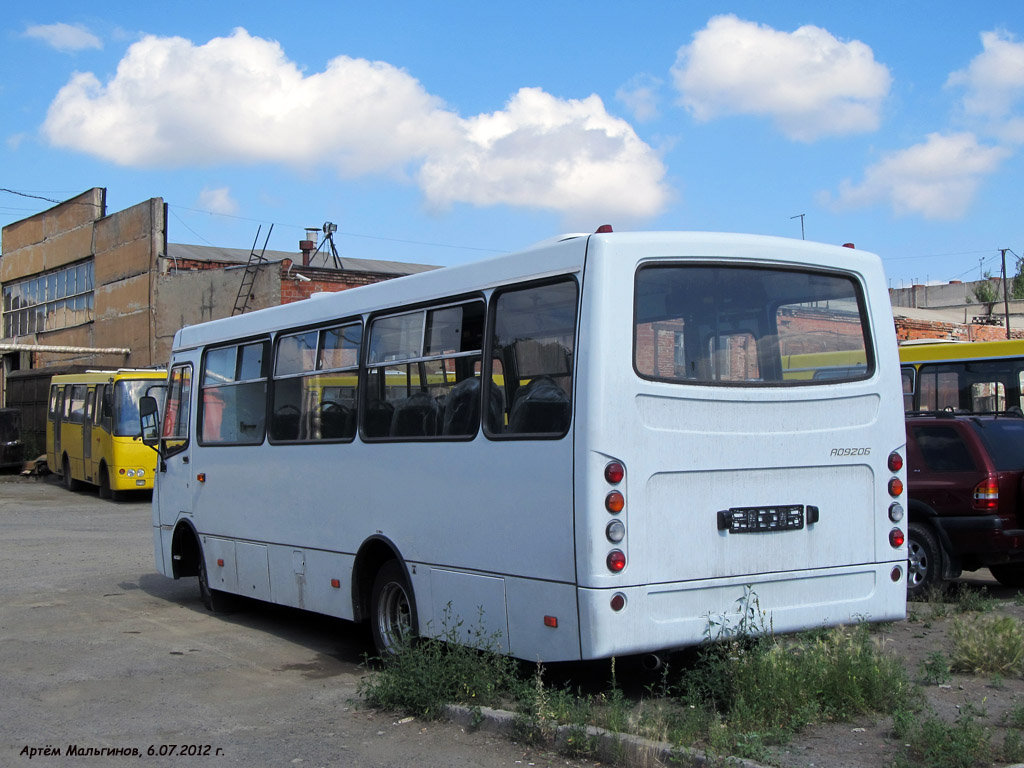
[3,261,94,338]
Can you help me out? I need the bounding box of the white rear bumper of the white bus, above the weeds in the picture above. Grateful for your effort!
[579,561,906,658]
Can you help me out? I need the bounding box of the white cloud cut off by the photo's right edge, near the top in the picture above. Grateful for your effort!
[946,30,1024,141]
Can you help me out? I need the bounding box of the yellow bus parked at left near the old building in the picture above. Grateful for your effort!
[46,369,167,501]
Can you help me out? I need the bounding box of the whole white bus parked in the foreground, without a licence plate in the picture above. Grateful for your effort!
[143,227,907,662]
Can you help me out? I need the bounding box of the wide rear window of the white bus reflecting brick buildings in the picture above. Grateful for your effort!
[634,264,873,386]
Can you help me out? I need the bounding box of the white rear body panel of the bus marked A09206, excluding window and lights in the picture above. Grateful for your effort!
[575,236,906,658]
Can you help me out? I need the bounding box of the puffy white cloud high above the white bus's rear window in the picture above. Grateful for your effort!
[672,14,892,141]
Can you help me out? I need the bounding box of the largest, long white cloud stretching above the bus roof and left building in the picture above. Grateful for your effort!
[43,29,667,216]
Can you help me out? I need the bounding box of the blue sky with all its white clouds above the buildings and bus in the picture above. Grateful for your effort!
[0,0,1024,288]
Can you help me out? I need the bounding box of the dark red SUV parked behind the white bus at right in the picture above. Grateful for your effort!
[906,412,1024,597]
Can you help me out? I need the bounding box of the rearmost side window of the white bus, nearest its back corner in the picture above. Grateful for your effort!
[487,279,579,437]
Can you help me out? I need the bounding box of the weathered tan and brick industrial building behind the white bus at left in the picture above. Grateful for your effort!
[0,187,434,442]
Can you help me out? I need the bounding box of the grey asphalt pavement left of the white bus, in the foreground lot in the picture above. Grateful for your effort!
[0,474,583,768]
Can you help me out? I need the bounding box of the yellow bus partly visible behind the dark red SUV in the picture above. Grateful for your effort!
[899,339,1024,413]
